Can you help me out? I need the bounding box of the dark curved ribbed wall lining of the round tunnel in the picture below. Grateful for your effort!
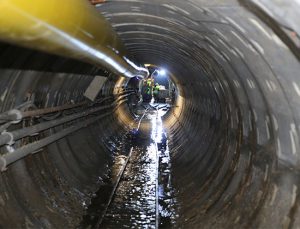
[0,0,300,228]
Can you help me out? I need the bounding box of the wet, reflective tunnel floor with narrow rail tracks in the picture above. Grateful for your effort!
[80,104,176,228]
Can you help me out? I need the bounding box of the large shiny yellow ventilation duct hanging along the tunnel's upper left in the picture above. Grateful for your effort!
[0,0,148,77]
